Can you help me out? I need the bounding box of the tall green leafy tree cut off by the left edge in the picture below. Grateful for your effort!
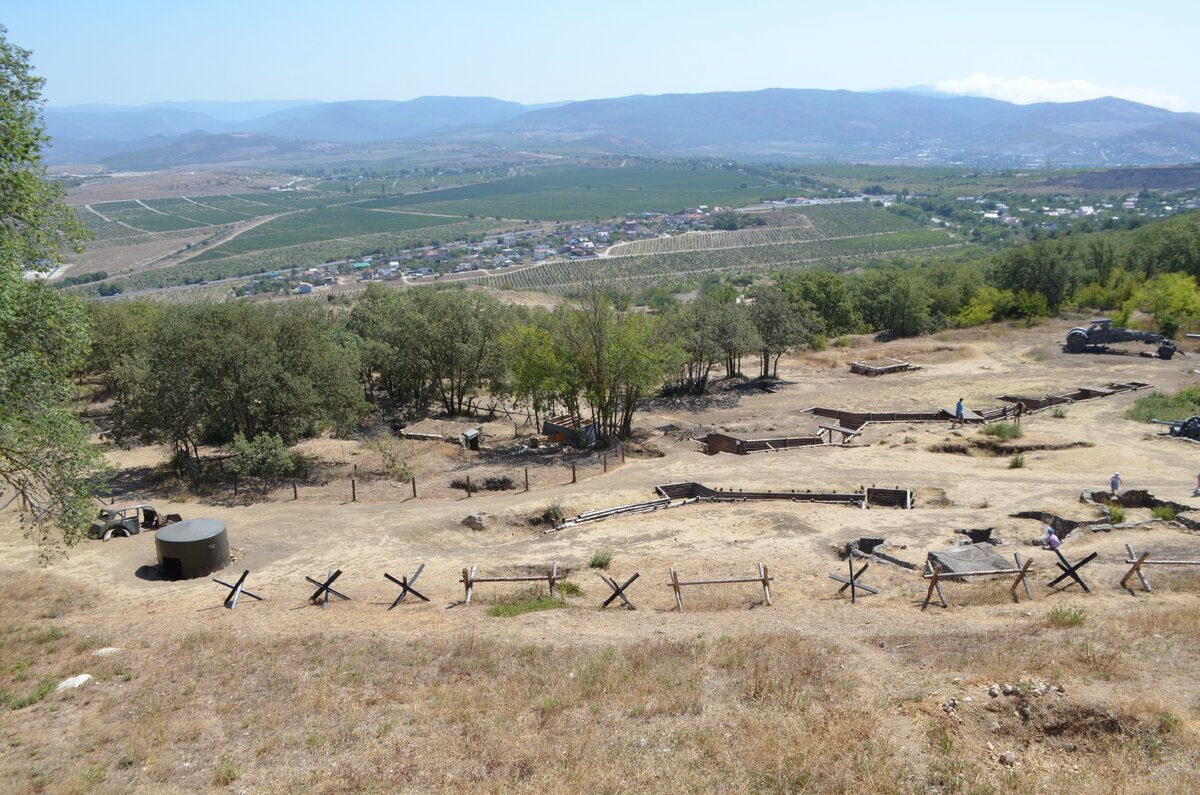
[0,25,104,556]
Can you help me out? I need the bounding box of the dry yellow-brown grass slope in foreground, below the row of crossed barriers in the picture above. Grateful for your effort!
[0,566,1200,793]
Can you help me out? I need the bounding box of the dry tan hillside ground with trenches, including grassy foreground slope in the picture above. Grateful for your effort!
[0,327,1200,793]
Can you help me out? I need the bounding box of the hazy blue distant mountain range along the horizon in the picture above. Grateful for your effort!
[46,89,1200,168]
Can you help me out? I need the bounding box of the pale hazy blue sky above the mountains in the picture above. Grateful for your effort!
[9,0,1200,110]
